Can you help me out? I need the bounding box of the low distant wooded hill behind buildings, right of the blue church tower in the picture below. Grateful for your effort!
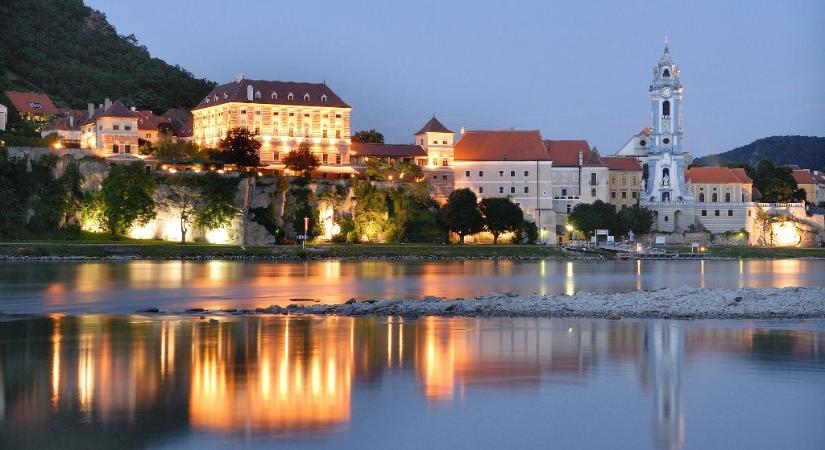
[694,136,825,170]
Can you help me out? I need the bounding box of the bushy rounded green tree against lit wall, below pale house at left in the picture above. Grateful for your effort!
[100,162,157,236]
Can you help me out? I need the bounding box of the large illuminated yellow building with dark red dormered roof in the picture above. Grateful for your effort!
[192,75,353,176]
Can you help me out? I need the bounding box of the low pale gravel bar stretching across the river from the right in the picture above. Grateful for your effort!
[251,287,825,319]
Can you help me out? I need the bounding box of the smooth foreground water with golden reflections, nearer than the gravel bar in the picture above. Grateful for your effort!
[0,315,825,449]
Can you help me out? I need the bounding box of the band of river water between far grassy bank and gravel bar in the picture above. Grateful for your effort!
[0,259,825,313]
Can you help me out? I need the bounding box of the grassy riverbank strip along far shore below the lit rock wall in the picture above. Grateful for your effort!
[0,241,568,261]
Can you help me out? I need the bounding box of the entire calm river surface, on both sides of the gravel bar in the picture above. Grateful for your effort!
[0,260,825,450]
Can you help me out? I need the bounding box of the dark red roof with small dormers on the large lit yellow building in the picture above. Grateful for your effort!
[192,79,349,110]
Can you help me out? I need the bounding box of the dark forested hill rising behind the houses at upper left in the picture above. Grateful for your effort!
[0,0,214,112]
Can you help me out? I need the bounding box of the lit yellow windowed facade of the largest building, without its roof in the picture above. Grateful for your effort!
[192,102,351,166]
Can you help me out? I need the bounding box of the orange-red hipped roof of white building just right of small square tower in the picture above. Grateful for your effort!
[454,130,550,161]
